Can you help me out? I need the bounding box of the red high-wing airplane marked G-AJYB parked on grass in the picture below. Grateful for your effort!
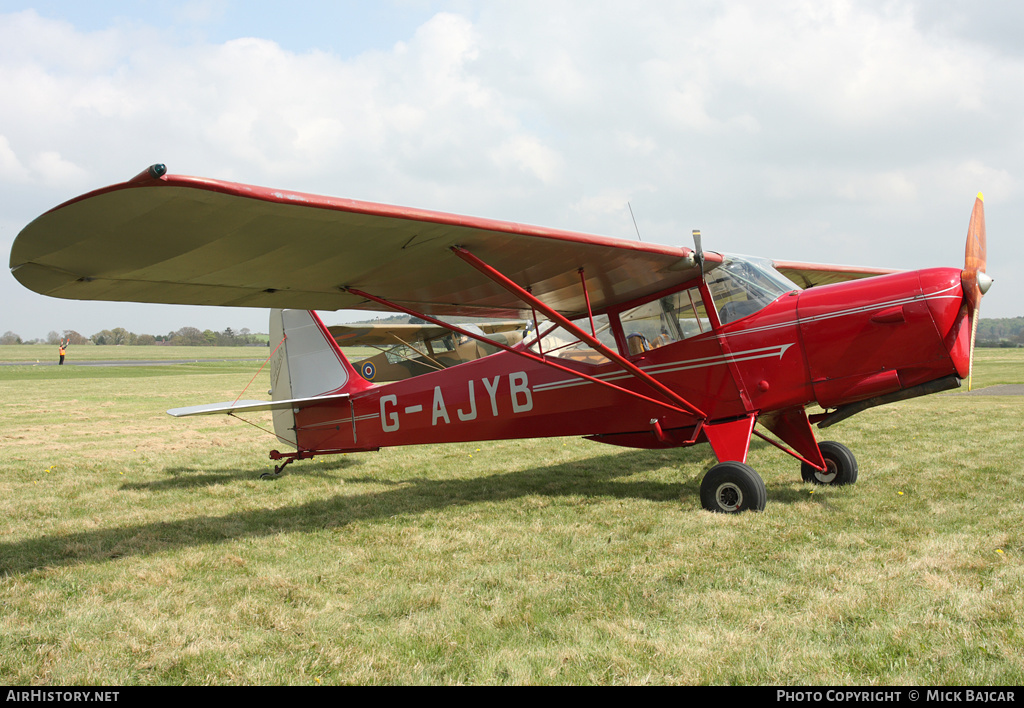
[10,165,991,512]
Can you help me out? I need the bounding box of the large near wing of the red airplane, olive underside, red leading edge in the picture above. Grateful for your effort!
[10,165,721,319]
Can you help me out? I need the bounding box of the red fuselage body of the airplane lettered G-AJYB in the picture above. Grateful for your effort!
[286,268,970,461]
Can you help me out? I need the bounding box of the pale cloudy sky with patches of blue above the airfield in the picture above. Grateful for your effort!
[0,0,1024,339]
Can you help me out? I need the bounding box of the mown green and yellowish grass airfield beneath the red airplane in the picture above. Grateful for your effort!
[0,347,1024,685]
